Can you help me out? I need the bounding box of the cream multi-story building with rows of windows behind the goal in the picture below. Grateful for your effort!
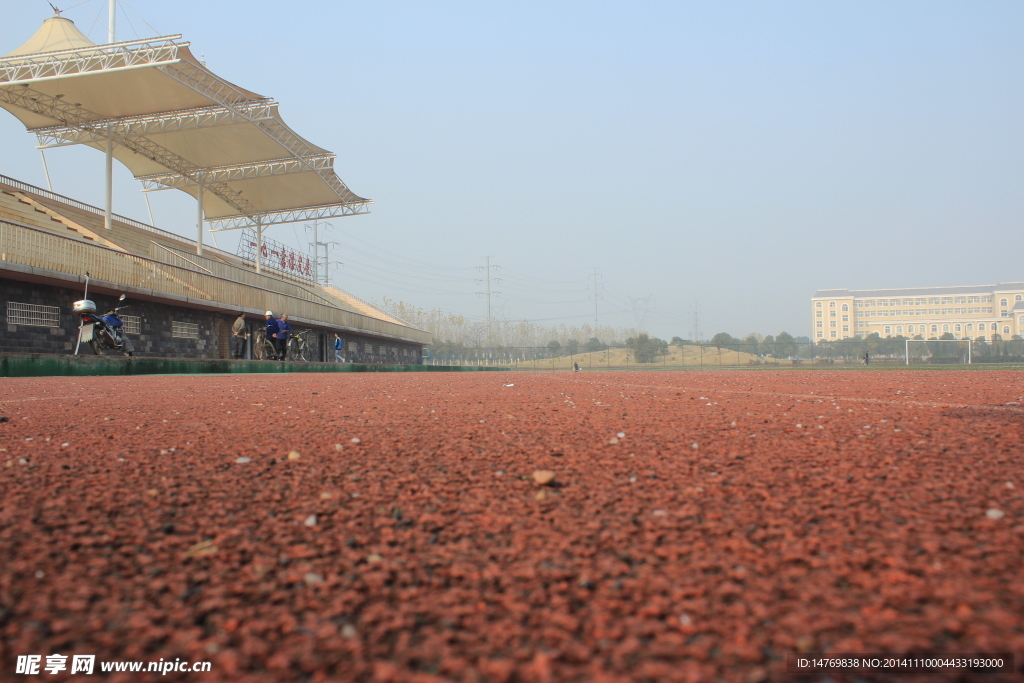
[811,283,1024,341]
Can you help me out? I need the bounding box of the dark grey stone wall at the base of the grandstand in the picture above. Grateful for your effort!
[0,279,422,365]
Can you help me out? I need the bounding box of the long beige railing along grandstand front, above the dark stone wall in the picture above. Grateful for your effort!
[0,220,430,343]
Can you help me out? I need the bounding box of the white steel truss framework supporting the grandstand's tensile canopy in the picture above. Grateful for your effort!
[0,35,372,230]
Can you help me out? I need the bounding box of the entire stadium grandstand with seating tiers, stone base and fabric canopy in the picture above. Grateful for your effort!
[0,13,430,364]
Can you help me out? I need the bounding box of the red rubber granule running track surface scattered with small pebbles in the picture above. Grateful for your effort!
[0,370,1024,683]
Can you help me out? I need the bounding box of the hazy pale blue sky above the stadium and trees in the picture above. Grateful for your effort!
[0,0,1024,339]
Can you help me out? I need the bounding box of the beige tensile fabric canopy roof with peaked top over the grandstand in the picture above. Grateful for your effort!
[0,16,371,229]
